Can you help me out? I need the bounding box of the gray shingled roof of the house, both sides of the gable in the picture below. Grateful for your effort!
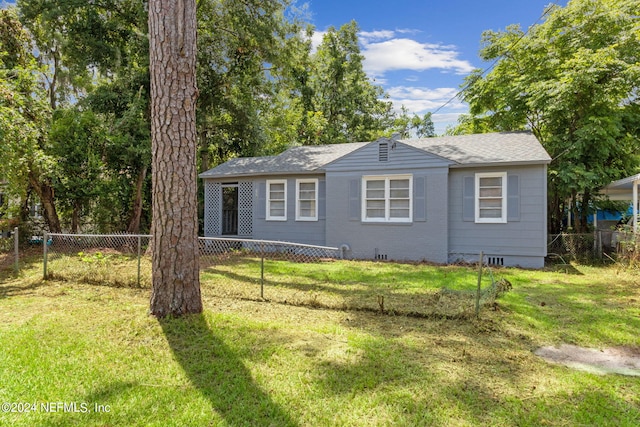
[200,132,551,178]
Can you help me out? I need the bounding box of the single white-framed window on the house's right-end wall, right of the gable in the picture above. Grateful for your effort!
[475,172,507,223]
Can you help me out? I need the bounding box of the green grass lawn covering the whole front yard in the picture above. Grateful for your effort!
[0,260,640,426]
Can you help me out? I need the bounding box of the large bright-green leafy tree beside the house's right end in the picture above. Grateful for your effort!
[463,0,640,232]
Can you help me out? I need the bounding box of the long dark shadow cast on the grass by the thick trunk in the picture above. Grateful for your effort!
[160,314,297,426]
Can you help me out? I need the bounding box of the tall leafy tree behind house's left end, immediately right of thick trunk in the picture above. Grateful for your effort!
[197,0,304,164]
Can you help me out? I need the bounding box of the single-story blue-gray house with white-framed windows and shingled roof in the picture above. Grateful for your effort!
[200,132,551,268]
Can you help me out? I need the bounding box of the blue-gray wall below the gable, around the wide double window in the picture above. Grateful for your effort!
[327,167,448,263]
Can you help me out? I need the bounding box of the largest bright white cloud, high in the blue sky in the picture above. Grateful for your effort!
[362,38,474,76]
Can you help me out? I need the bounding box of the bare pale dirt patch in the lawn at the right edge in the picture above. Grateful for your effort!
[534,344,640,376]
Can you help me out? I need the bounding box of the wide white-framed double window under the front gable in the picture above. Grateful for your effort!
[362,175,413,222]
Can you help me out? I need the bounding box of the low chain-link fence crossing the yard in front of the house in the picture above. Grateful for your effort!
[43,234,510,318]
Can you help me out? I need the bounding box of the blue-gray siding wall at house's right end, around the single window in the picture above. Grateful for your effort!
[449,165,547,268]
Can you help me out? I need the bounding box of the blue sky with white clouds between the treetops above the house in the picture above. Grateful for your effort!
[307,0,567,133]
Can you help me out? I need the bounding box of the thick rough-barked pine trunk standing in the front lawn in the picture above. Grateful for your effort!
[149,0,202,317]
